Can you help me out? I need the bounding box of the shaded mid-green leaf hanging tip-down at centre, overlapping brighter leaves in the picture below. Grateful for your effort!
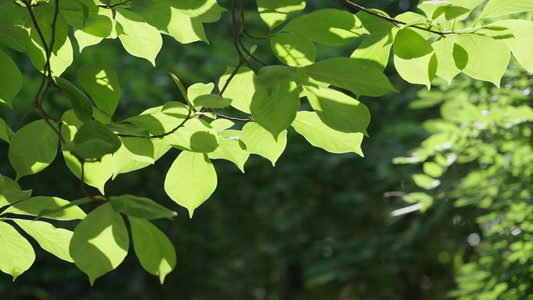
[250,82,300,139]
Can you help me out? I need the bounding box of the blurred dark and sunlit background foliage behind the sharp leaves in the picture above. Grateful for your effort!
[0,0,533,300]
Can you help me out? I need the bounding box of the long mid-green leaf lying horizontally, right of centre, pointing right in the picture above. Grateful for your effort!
[300,57,396,97]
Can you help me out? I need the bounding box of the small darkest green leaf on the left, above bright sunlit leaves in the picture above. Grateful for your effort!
[72,120,122,160]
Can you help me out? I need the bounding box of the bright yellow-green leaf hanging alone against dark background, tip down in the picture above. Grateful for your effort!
[165,151,217,218]
